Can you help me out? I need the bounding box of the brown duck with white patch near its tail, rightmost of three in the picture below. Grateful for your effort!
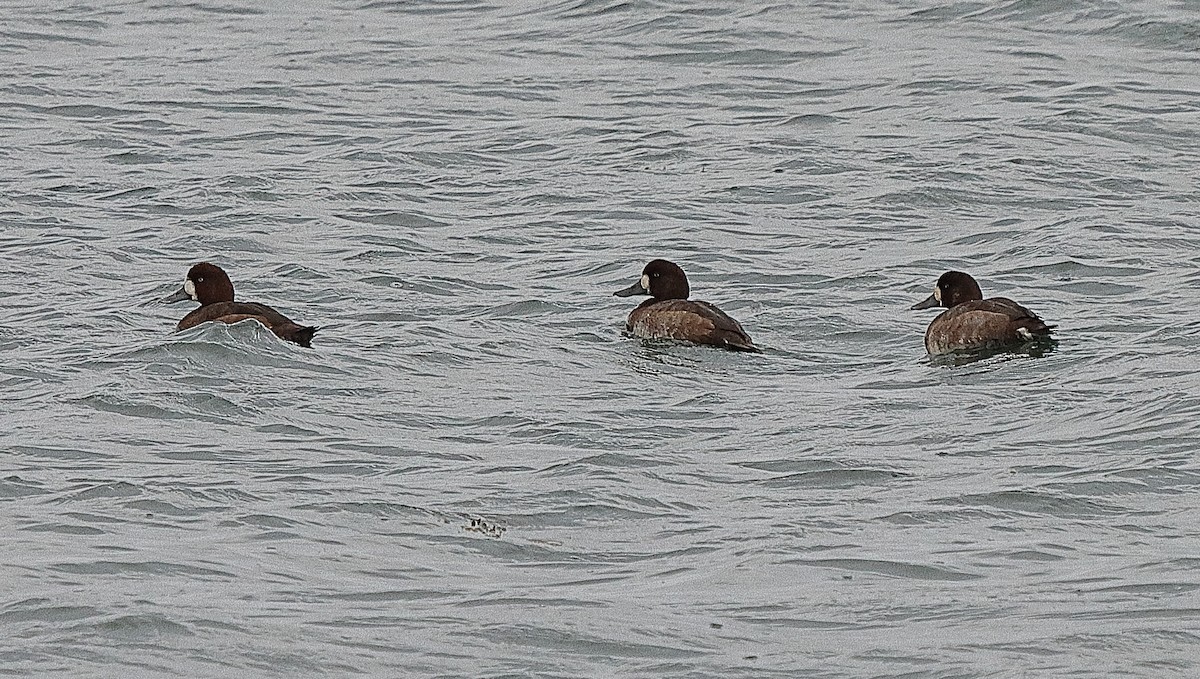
[912,271,1055,355]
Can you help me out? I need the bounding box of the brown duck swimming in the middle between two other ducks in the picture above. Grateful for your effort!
[613,259,761,353]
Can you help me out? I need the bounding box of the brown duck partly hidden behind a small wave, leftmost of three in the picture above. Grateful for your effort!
[162,262,319,348]
